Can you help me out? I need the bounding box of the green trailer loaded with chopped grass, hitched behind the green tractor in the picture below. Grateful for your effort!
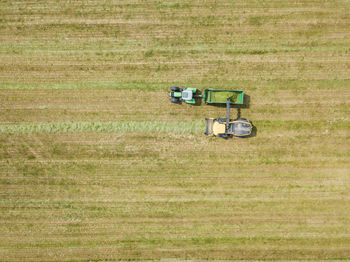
[203,89,244,105]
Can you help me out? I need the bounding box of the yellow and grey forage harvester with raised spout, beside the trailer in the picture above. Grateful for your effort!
[204,98,253,138]
